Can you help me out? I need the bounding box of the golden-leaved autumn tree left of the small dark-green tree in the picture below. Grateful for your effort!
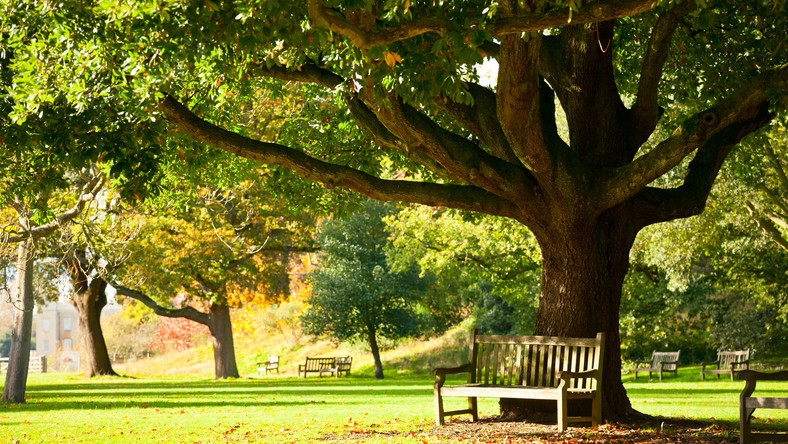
[112,173,314,378]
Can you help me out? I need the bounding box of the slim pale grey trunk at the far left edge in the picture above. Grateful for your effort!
[3,239,35,403]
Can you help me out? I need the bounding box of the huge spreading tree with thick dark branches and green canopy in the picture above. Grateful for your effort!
[0,0,788,418]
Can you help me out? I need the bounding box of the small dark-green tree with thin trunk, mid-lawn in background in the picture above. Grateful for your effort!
[301,201,425,379]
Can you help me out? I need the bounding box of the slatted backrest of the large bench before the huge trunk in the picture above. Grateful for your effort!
[469,329,605,389]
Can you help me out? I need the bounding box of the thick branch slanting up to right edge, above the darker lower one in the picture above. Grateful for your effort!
[598,65,788,210]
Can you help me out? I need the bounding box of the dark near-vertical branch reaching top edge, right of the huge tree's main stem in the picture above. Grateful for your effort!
[632,2,695,146]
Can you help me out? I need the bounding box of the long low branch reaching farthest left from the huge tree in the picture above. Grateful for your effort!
[159,96,521,220]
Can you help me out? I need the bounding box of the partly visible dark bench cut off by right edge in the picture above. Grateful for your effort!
[737,370,788,444]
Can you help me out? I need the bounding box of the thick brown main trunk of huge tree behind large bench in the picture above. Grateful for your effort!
[501,206,637,419]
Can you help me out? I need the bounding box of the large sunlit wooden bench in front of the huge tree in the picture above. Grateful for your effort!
[432,330,605,431]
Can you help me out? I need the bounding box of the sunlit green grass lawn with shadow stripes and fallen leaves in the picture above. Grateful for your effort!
[0,369,788,444]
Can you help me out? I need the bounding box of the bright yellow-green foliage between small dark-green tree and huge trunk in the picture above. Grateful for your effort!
[386,205,541,334]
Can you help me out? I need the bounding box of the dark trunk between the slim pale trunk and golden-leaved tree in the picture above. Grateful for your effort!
[71,274,117,378]
